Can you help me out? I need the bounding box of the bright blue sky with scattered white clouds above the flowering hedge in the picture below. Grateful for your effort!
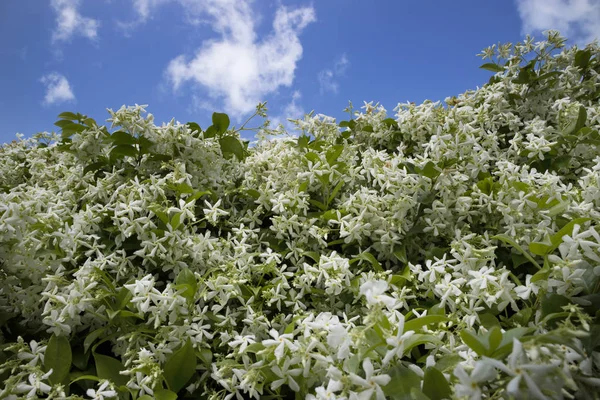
[0,0,600,143]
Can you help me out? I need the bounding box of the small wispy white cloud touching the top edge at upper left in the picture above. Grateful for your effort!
[50,0,100,42]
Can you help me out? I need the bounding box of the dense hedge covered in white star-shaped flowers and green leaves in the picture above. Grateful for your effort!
[0,32,600,400]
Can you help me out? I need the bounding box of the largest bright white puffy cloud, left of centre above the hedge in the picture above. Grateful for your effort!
[165,0,315,116]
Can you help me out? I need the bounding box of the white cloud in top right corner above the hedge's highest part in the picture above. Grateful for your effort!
[517,0,600,43]
